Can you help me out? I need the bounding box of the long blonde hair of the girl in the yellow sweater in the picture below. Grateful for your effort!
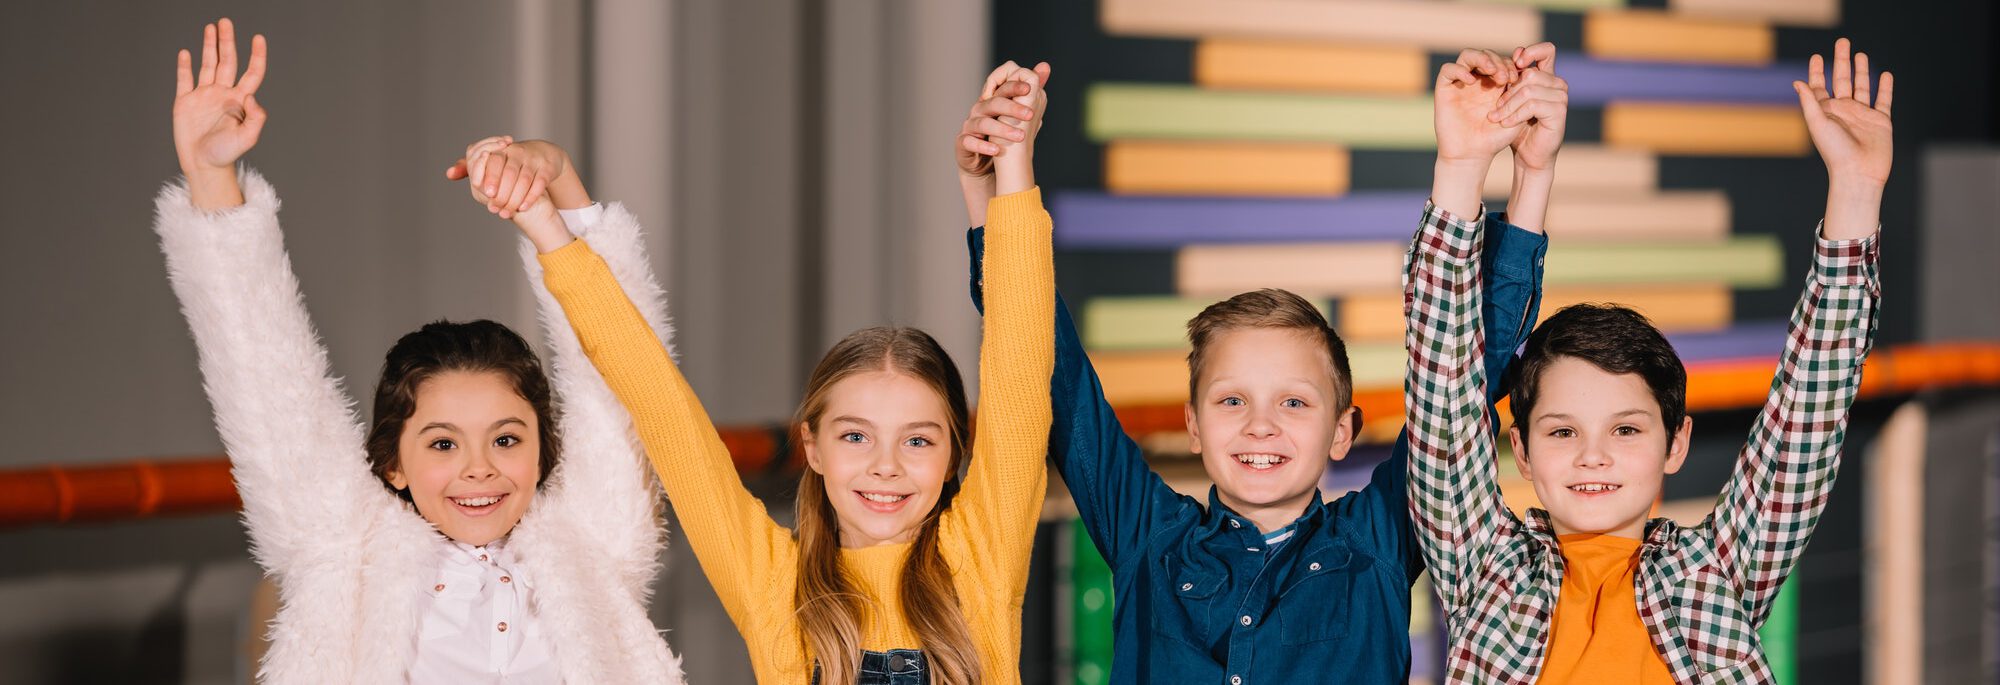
[792,326,980,685]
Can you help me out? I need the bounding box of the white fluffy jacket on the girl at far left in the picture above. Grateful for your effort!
[154,170,682,685]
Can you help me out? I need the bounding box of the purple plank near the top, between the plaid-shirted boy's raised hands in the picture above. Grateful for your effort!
[1556,52,1806,106]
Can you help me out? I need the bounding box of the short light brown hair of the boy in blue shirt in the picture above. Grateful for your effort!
[1188,288,1360,419]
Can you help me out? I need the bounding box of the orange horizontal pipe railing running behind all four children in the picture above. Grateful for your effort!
[0,343,2000,529]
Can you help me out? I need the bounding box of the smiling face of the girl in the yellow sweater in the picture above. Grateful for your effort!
[800,371,952,547]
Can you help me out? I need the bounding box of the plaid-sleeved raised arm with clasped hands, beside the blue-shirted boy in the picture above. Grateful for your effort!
[1404,44,1566,615]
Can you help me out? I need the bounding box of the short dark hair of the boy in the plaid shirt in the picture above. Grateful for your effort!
[1506,302,1688,441]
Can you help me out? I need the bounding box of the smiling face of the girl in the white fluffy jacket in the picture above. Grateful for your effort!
[386,371,542,545]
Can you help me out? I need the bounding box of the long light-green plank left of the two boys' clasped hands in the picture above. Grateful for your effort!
[1084,82,1436,150]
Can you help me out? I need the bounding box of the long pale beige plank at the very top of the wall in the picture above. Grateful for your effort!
[1098,0,1542,52]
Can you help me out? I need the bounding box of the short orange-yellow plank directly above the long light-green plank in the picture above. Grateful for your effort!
[1194,38,1430,94]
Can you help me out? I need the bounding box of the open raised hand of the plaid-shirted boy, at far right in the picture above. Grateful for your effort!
[1792,38,1896,240]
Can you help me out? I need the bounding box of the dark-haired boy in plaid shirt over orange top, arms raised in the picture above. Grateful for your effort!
[1404,40,1892,683]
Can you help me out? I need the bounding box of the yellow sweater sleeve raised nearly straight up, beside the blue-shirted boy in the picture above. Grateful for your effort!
[940,188,1056,600]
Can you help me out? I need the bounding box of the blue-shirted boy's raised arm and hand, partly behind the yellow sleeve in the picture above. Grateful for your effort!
[956,62,1182,569]
